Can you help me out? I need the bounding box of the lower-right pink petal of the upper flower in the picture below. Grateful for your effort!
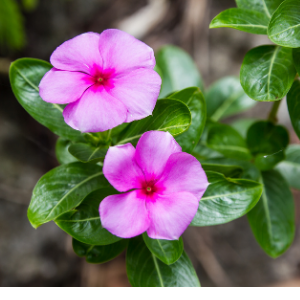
[109,69,161,122]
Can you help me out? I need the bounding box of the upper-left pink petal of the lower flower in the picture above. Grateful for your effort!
[103,144,145,192]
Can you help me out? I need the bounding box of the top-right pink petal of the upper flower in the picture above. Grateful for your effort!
[99,29,155,74]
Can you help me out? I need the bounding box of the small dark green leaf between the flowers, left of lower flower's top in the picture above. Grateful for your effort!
[68,143,108,163]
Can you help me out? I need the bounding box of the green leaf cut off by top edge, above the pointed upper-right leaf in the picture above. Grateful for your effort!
[235,0,283,19]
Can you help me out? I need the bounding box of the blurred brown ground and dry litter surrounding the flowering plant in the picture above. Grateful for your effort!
[0,0,300,286]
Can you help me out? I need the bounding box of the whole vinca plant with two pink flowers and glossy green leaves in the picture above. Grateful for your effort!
[10,0,300,287]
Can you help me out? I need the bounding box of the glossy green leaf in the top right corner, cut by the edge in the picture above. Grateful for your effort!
[268,0,300,48]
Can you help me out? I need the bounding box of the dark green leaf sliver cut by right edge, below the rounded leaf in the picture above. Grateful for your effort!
[286,79,300,139]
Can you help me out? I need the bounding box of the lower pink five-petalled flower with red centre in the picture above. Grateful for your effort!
[99,131,208,240]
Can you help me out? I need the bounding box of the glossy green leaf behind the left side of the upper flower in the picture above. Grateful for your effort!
[9,58,83,141]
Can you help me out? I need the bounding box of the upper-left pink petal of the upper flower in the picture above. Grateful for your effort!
[50,32,103,74]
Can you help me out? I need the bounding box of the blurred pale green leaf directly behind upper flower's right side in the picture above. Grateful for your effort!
[155,45,203,98]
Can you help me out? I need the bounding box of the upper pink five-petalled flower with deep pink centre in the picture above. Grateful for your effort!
[39,29,161,132]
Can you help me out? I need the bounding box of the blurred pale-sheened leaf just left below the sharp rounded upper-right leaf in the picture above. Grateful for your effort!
[205,76,256,121]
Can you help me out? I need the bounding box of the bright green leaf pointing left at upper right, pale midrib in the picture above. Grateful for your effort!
[209,8,269,34]
